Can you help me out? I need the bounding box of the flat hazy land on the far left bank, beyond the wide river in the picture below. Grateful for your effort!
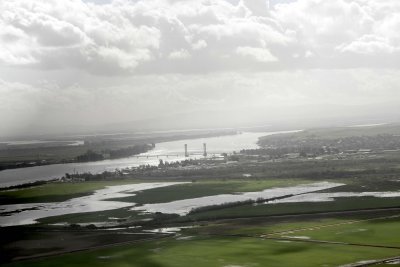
[0,130,237,172]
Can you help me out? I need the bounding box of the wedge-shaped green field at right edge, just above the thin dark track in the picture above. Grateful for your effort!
[222,214,400,248]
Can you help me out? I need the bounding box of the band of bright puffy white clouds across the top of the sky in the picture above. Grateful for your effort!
[0,0,400,75]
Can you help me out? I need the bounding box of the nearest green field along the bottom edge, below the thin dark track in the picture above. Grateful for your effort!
[4,237,399,267]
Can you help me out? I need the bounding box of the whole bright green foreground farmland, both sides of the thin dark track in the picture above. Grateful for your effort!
[4,215,400,267]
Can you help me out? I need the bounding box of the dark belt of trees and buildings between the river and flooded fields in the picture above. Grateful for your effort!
[61,151,399,184]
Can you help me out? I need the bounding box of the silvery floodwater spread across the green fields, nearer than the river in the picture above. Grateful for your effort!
[0,181,400,227]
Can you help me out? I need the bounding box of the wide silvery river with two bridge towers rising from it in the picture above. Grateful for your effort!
[0,131,295,187]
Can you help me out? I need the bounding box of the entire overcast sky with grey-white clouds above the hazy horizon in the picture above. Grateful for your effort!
[0,0,400,136]
